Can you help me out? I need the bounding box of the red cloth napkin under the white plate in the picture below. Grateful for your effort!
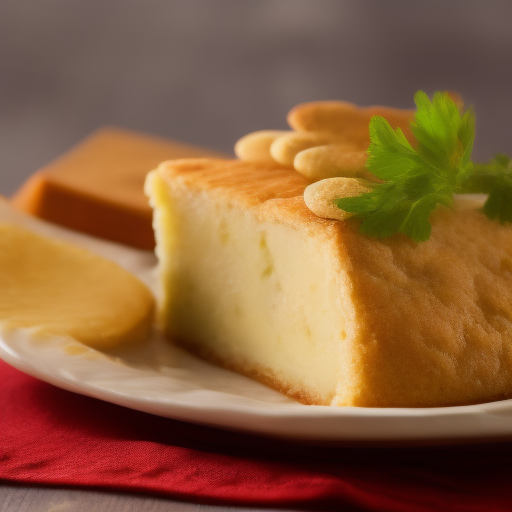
[0,361,512,512]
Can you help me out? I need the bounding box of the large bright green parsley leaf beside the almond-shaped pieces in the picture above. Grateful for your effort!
[334,91,476,242]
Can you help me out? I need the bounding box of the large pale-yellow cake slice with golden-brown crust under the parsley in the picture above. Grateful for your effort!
[146,159,512,407]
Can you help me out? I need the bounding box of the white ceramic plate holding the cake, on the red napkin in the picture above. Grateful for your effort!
[0,202,512,444]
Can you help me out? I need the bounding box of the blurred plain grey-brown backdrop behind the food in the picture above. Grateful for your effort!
[0,0,512,195]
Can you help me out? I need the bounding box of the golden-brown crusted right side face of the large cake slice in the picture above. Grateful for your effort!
[345,209,512,407]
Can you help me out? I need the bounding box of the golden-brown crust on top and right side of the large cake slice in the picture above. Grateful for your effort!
[154,159,512,407]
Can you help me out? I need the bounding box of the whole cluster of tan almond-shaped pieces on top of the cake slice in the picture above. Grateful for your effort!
[235,101,414,220]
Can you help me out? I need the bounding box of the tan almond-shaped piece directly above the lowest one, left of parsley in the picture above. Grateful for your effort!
[293,144,372,181]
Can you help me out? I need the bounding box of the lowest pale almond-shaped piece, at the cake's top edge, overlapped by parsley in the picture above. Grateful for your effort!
[304,178,371,220]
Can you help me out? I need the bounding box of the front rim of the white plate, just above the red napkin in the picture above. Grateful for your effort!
[0,333,512,445]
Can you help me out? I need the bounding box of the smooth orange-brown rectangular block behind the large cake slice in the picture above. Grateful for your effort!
[12,128,225,249]
